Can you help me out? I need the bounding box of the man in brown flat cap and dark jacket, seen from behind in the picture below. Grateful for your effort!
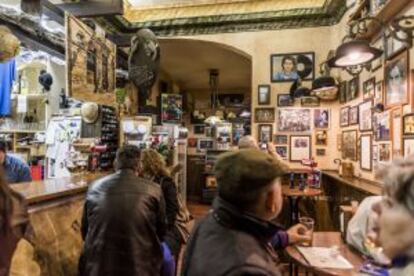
[183,149,308,276]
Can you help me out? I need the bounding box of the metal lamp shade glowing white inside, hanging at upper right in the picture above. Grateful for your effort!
[328,40,383,67]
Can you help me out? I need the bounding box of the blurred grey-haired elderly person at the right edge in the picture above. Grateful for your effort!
[373,155,414,275]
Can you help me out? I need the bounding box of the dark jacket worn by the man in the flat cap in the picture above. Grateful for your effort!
[183,198,280,276]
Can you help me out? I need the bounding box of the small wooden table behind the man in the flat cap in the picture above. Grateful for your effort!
[282,185,322,225]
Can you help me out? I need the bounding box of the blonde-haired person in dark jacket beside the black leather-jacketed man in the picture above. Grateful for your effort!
[141,149,183,260]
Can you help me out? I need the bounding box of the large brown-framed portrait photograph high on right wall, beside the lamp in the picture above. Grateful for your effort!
[384,51,409,108]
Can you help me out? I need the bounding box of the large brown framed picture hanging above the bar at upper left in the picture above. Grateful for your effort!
[65,15,116,106]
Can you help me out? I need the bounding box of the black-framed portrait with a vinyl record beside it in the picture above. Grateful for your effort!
[270,52,315,82]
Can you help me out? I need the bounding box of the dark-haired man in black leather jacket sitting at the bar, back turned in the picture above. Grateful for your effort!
[79,146,166,276]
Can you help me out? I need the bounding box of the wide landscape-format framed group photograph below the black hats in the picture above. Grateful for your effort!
[277,108,312,132]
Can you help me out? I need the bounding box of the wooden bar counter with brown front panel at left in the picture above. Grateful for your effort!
[10,173,105,276]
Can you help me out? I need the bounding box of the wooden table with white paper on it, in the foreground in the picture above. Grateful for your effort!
[285,232,364,276]
